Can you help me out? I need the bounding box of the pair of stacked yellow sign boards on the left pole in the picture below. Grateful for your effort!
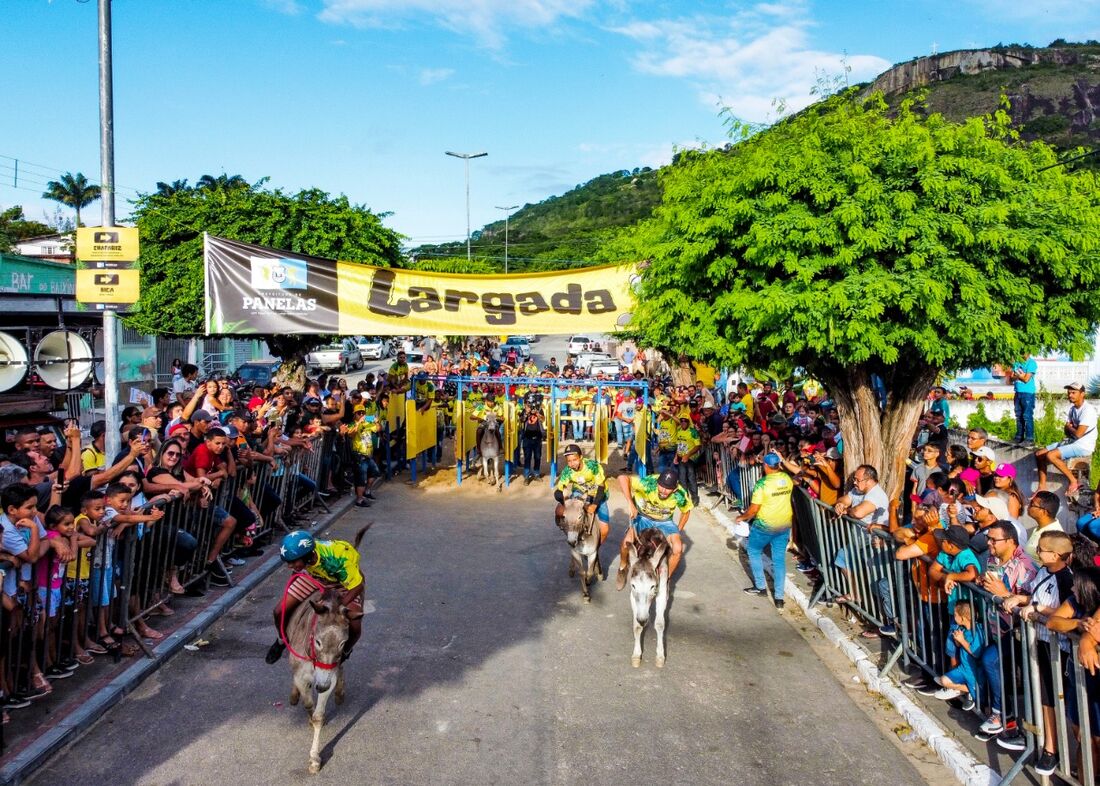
[76,226,141,310]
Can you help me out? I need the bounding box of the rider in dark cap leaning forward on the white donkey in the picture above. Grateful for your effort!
[615,469,693,589]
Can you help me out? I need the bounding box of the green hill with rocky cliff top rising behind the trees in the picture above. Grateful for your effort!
[413,41,1100,273]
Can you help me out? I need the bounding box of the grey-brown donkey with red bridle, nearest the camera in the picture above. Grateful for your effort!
[286,589,363,775]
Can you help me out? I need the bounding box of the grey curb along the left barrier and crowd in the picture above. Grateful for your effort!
[0,496,352,786]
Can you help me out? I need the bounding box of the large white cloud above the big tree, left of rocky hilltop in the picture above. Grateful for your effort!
[613,0,891,121]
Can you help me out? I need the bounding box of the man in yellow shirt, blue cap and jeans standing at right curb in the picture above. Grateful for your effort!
[737,451,794,609]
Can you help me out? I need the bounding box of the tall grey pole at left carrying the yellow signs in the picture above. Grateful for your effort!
[99,0,121,462]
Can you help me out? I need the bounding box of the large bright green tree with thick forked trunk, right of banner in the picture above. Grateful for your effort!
[617,92,1100,494]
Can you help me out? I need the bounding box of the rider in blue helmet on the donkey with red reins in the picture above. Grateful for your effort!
[264,530,365,663]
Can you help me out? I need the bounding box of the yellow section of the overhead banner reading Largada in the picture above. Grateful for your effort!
[336,262,636,335]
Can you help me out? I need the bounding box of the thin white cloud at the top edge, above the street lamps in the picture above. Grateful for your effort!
[320,0,595,49]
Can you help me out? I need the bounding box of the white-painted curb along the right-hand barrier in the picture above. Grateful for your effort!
[704,508,1001,786]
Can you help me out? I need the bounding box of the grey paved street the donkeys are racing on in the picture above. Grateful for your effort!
[25,473,946,785]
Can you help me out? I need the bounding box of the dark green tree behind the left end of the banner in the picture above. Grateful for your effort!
[127,176,402,373]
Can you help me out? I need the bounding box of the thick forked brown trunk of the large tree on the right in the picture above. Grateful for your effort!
[822,364,938,499]
